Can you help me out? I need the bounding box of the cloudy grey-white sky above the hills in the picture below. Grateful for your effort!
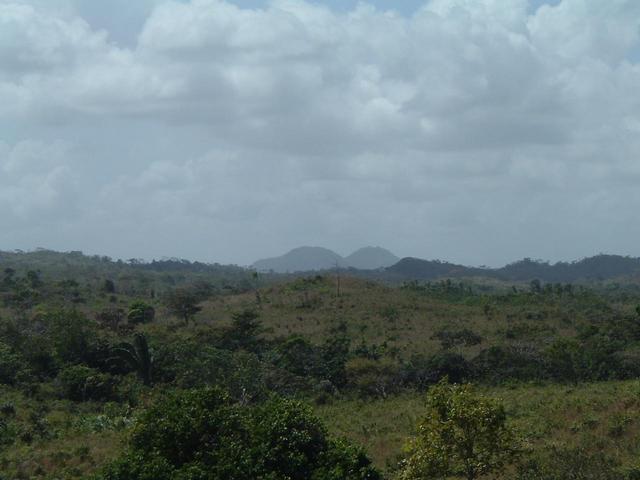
[0,0,640,266]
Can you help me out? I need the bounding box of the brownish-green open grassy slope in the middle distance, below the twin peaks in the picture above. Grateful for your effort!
[197,276,620,357]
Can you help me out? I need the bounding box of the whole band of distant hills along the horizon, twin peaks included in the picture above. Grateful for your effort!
[5,247,640,284]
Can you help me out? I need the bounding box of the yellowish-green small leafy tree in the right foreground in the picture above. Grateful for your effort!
[400,379,519,480]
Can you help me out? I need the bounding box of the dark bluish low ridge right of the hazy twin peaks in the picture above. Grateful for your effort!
[385,255,640,283]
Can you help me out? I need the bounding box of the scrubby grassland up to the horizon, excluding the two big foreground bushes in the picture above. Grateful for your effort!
[0,252,640,479]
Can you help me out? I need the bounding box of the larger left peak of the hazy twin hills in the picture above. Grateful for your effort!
[253,247,346,273]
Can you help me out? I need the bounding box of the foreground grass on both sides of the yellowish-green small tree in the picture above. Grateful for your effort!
[316,380,640,469]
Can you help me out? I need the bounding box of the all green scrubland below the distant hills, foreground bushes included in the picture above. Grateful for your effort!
[0,250,640,480]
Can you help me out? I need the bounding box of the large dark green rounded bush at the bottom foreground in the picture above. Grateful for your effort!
[103,388,380,480]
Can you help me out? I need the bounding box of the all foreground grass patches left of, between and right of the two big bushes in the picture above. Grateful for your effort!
[5,381,640,479]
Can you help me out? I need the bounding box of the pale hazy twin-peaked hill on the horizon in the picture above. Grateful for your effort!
[253,247,399,273]
